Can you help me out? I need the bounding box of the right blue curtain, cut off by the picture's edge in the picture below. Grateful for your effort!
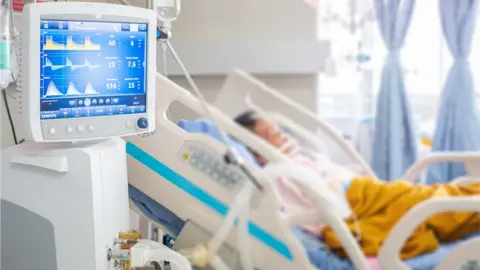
[427,0,480,183]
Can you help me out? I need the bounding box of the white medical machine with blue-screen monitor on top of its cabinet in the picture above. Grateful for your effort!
[1,2,157,270]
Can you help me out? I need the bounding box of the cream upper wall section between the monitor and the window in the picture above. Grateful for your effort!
[159,0,329,75]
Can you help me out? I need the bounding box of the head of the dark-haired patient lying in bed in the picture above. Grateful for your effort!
[234,111,287,164]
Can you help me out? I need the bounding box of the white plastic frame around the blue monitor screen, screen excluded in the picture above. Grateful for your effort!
[20,2,157,142]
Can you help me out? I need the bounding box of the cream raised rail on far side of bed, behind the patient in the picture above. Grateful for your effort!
[213,69,376,176]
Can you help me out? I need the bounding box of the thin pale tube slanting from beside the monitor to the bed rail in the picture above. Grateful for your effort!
[165,40,263,191]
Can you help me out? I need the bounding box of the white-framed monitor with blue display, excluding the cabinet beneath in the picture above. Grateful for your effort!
[20,3,156,141]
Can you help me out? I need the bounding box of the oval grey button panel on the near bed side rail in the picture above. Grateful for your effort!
[180,142,245,189]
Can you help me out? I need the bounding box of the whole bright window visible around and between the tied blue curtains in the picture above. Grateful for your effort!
[318,0,480,119]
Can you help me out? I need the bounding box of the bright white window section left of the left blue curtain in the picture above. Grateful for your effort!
[317,0,376,117]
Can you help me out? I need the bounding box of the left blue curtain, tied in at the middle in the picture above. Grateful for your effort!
[372,0,417,180]
